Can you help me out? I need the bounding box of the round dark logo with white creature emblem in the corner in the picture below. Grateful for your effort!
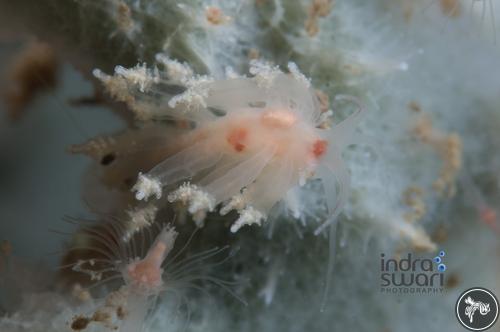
[455,287,498,331]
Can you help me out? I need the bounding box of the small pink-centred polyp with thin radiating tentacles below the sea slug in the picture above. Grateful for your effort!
[63,219,239,332]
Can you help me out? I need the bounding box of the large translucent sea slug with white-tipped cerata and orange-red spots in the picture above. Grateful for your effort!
[89,59,363,233]
